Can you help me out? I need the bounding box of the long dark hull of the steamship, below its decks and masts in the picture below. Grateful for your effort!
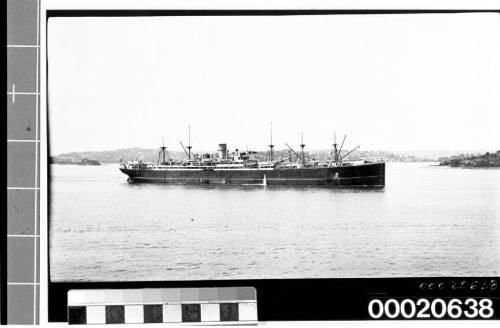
[120,163,385,187]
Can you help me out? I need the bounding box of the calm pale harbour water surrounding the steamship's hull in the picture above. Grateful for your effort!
[50,163,500,281]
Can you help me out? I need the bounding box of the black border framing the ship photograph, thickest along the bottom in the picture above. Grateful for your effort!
[43,9,500,322]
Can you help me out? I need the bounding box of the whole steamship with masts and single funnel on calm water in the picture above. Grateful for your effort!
[120,127,385,188]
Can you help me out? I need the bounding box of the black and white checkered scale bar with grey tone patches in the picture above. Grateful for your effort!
[68,287,257,325]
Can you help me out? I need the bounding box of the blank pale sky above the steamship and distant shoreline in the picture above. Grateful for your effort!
[48,13,500,154]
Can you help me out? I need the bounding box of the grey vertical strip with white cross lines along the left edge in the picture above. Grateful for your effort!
[6,0,40,324]
